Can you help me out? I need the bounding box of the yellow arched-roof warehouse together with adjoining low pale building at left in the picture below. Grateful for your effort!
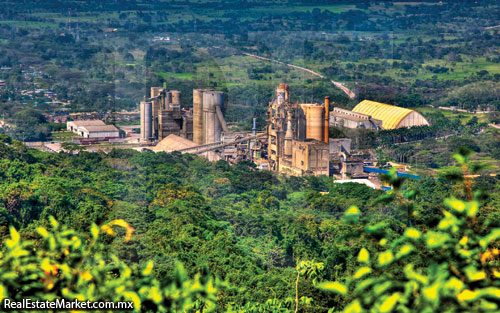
[330,100,429,130]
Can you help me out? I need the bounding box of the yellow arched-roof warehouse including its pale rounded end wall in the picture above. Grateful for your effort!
[352,100,429,129]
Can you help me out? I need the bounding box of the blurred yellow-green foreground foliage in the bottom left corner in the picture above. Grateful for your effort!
[0,218,221,312]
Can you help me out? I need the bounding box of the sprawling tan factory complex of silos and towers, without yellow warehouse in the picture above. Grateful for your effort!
[141,84,392,179]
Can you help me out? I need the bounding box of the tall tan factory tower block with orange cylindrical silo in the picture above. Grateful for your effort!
[266,84,330,175]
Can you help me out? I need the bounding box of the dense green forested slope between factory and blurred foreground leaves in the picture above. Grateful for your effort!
[0,137,500,312]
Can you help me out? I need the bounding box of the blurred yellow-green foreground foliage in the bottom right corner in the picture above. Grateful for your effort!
[318,148,500,313]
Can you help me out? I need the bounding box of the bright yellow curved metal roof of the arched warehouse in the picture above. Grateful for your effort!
[352,100,415,129]
